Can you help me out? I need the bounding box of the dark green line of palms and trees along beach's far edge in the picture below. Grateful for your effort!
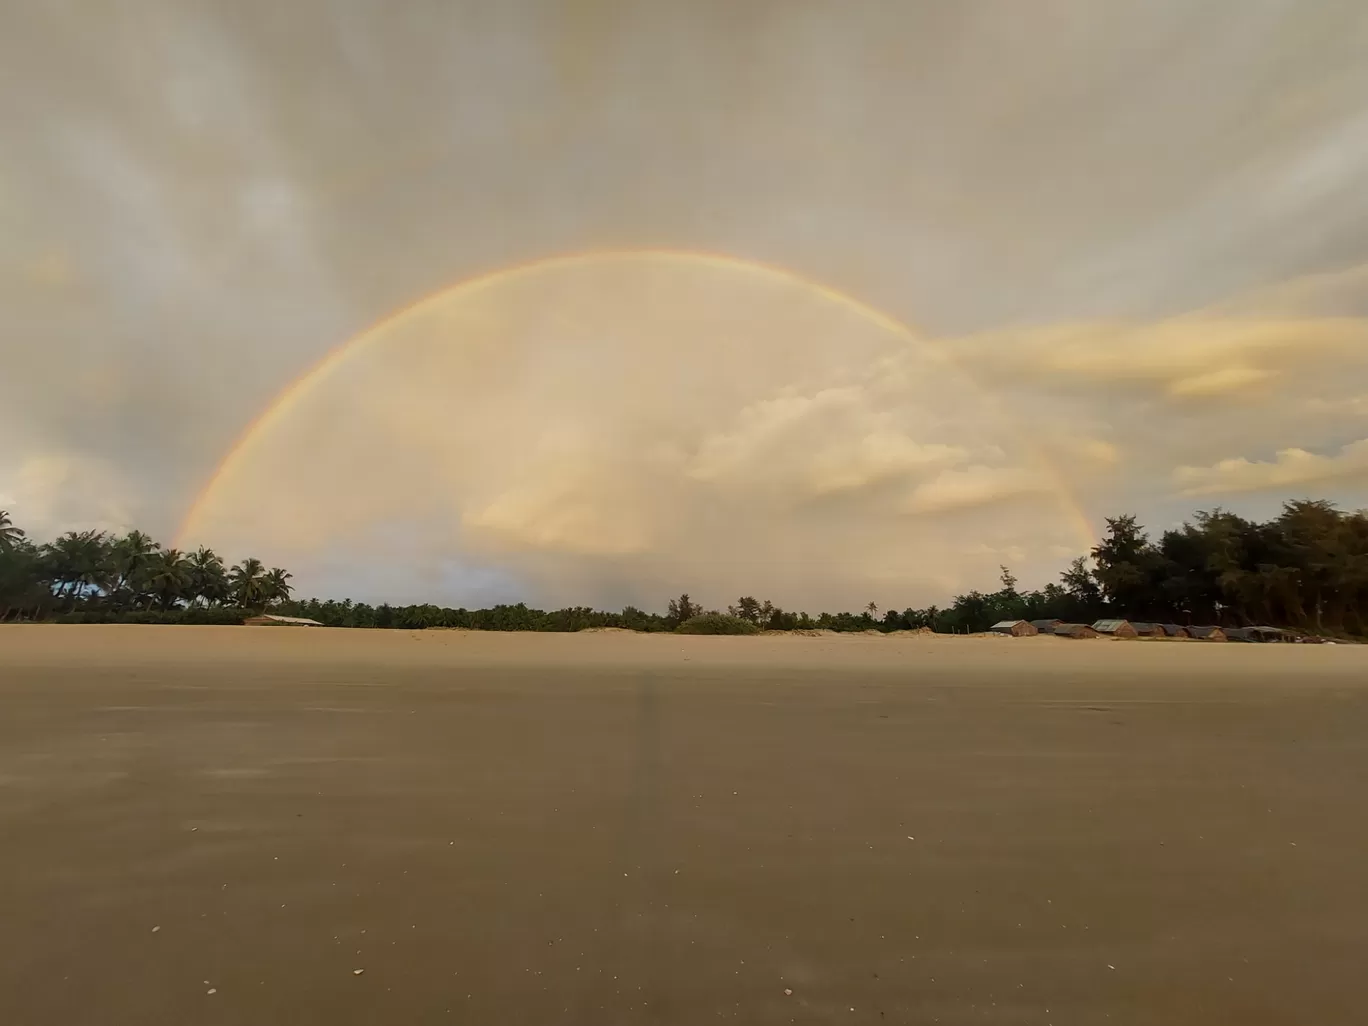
[0,499,1368,636]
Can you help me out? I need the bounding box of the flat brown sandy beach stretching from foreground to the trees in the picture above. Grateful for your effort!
[0,625,1368,1026]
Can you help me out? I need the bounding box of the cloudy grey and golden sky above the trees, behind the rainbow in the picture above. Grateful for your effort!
[0,0,1368,607]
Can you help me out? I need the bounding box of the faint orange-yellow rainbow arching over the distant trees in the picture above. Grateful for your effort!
[174,249,1096,549]
